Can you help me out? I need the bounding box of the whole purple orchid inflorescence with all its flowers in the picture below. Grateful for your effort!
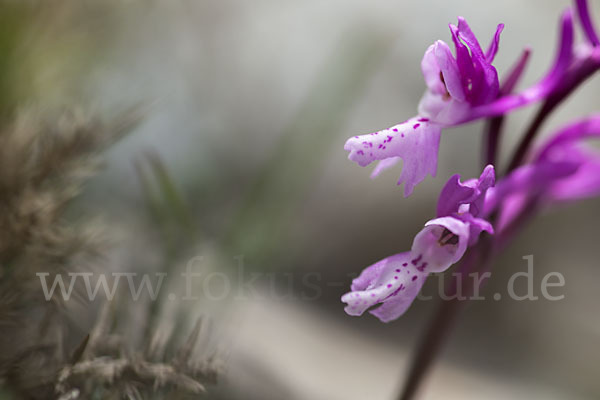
[342,0,600,322]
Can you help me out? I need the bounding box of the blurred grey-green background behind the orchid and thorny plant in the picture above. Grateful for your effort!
[0,0,600,400]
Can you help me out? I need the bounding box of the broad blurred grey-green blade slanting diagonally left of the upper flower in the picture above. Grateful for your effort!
[224,26,392,265]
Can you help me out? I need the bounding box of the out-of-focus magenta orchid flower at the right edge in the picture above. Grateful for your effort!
[483,114,600,230]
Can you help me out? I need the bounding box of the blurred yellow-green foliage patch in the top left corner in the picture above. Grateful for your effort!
[0,1,120,120]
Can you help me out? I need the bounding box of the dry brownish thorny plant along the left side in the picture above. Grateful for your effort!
[0,109,218,400]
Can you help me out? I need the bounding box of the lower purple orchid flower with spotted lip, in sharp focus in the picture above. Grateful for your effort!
[342,165,495,322]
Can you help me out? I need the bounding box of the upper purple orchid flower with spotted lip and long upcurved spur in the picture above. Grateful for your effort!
[344,14,573,196]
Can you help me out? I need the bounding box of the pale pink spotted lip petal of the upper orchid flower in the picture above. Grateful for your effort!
[344,117,441,196]
